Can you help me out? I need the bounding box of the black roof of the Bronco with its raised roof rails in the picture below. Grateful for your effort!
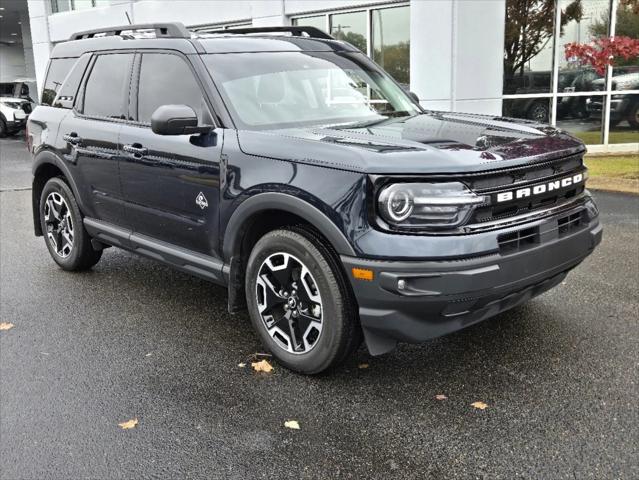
[51,23,358,58]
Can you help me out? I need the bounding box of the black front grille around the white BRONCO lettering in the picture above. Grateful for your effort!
[466,155,586,227]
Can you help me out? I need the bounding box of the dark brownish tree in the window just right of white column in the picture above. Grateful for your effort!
[504,0,583,86]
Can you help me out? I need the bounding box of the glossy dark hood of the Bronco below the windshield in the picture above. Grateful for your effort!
[238,112,585,174]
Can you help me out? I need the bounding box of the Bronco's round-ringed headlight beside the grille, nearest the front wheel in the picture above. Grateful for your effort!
[377,182,487,229]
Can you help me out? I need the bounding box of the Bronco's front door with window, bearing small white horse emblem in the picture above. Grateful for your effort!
[120,51,223,257]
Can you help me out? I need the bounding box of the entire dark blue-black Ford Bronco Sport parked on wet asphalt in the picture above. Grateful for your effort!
[28,23,602,373]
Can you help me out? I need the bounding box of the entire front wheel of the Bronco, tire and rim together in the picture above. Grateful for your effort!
[245,227,362,374]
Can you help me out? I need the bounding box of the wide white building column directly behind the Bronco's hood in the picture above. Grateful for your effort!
[410,0,506,115]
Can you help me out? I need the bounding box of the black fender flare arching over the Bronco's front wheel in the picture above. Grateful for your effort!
[222,192,356,261]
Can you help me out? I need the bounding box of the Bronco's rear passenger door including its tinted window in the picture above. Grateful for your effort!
[60,53,134,225]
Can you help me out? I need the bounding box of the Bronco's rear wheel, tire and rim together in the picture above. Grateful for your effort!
[40,177,102,271]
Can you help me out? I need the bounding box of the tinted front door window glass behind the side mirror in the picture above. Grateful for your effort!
[138,53,206,123]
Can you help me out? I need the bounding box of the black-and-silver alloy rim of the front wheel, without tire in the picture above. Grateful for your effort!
[255,252,323,354]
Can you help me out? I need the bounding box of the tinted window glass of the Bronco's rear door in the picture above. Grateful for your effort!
[82,53,133,118]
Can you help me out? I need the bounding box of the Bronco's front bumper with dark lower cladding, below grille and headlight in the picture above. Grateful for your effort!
[341,201,602,355]
